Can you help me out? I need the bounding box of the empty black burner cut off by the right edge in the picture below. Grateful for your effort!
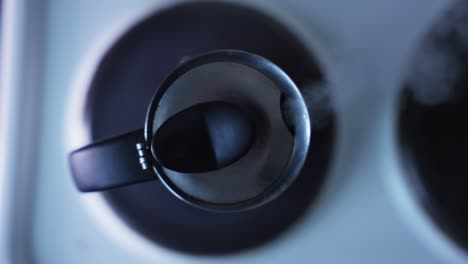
[398,4,468,250]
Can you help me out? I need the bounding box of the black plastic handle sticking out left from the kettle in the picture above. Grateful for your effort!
[69,129,157,192]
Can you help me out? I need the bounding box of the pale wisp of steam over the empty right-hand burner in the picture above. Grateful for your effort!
[409,0,468,105]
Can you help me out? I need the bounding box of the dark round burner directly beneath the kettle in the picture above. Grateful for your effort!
[86,2,335,254]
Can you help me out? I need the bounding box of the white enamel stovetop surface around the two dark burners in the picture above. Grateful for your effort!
[0,0,468,264]
